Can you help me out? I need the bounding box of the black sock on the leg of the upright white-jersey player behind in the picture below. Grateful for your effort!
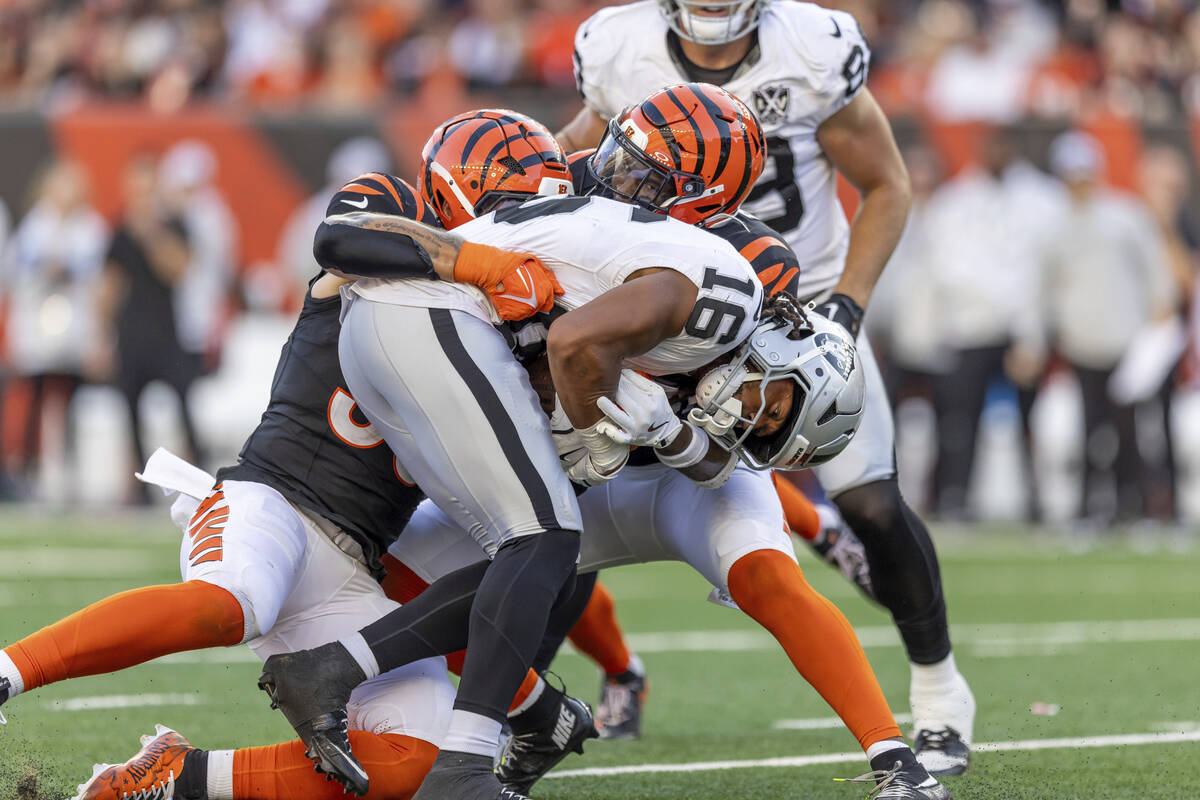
[834,479,950,664]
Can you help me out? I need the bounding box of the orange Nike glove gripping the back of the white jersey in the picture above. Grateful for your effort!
[454,241,563,320]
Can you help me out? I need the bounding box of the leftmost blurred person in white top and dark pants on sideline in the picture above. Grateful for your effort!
[6,161,108,496]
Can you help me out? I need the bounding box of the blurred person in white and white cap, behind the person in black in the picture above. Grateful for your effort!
[158,140,238,368]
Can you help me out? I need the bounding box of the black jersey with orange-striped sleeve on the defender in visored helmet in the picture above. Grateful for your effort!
[566,150,800,297]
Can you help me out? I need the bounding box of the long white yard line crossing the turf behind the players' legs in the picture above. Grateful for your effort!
[145,618,1200,664]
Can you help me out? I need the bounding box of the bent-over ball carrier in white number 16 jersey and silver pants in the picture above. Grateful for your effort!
[260,90,777,800]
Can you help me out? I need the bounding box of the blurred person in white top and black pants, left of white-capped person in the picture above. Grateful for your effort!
[925,131,1062,518]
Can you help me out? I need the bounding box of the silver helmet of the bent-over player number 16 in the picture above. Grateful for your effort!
[689,297,865,470]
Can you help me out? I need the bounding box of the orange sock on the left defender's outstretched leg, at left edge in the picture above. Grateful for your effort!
[5,581,245,691]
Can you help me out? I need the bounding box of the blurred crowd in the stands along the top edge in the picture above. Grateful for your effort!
[7,0,1200,121]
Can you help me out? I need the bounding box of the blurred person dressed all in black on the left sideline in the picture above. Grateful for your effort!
[100,155,204,503]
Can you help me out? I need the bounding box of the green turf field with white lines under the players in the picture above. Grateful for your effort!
[0,512,1200,800]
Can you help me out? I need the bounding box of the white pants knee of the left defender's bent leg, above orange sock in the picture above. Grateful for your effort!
[346,657,455,746]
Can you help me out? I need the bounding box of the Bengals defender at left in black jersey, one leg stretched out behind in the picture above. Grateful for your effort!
[0,139,573,800]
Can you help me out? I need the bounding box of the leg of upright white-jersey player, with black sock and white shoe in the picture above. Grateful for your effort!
[814,336,974,775]
